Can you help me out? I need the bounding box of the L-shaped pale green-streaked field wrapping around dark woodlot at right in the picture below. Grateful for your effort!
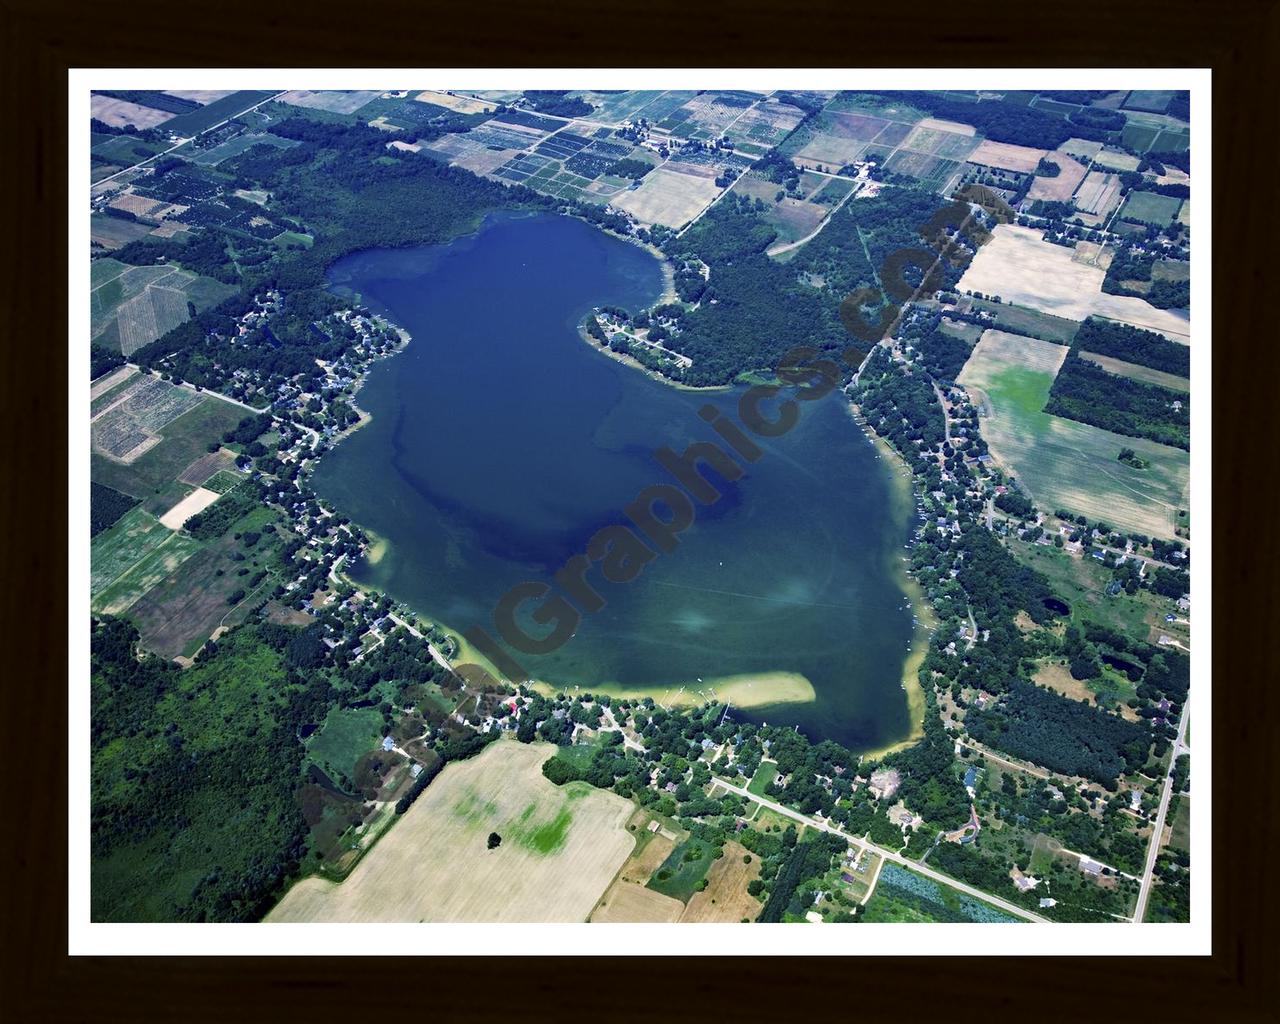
[959,330,1190,539]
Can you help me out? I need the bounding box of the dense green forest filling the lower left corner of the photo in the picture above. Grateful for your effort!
[91,620,307,922]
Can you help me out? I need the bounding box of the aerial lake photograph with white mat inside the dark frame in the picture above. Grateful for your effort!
[77,69,1210,952]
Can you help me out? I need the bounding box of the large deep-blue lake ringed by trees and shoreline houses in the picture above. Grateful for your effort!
[312,215,913,750]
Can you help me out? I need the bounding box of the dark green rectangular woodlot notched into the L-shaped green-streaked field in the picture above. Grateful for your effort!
[1044,348,1190,449]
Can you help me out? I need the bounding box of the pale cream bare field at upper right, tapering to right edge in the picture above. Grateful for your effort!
[957,224,1190,343]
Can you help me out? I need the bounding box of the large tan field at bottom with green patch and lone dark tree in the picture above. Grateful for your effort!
[266,740,635,923]
